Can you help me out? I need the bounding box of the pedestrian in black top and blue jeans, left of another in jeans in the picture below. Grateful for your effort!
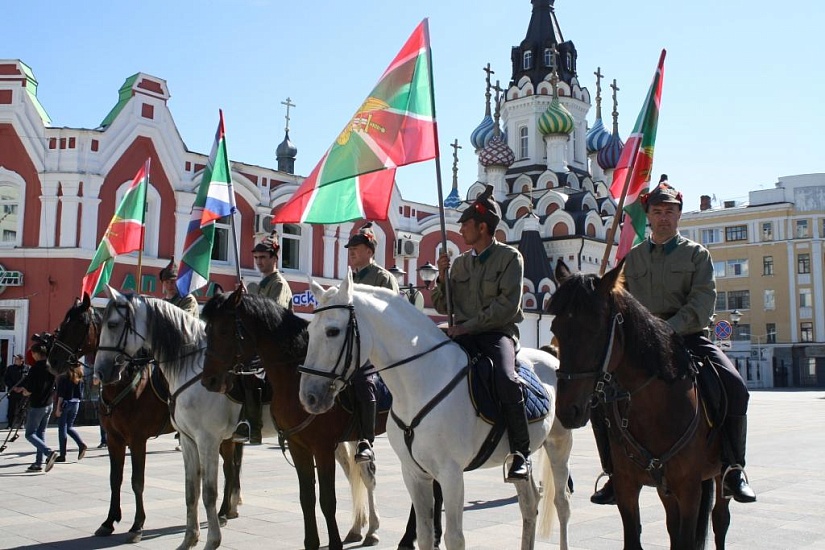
[15,342,57,472]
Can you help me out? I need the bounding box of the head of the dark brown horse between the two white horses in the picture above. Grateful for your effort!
[201,286,249,393]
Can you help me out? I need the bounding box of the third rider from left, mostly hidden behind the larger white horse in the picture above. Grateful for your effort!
[344,222,400,463]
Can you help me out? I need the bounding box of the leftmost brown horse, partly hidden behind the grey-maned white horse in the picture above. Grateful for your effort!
[48,295,243,543]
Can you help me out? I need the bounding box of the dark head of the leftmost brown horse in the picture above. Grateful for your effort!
[46,292,100,375]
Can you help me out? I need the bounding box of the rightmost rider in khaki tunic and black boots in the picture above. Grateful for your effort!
[590,179,756,504]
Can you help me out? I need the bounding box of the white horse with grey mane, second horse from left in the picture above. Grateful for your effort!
[95,286,364,550]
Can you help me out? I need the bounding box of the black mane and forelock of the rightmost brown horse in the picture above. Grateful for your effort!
[547,273,689,380]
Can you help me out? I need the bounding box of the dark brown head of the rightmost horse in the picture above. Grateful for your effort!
[547,260,624,429]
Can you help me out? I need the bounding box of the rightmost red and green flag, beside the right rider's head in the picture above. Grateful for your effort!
[610,50,667,262]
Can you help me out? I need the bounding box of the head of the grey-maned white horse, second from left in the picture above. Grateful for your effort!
[95,285,147,385]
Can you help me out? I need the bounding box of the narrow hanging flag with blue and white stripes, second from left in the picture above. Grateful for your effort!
[177,111,236,296]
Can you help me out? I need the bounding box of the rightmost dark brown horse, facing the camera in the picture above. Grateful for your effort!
[548,261,730,550]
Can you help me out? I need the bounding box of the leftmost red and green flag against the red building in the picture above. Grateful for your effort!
[80,159,150,298]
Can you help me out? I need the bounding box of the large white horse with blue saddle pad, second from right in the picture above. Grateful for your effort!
[300,274,572,550]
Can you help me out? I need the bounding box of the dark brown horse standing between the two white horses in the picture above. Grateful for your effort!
[201,289,440,550]
